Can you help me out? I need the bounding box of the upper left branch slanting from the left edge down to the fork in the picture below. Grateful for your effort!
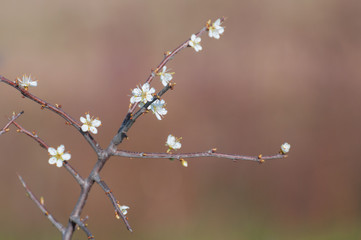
[0,75,101,154]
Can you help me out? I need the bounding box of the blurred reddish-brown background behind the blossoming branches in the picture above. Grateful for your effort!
[0,0,361,240]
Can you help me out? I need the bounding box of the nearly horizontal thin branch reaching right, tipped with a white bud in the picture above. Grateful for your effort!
[112,149,287,163]
